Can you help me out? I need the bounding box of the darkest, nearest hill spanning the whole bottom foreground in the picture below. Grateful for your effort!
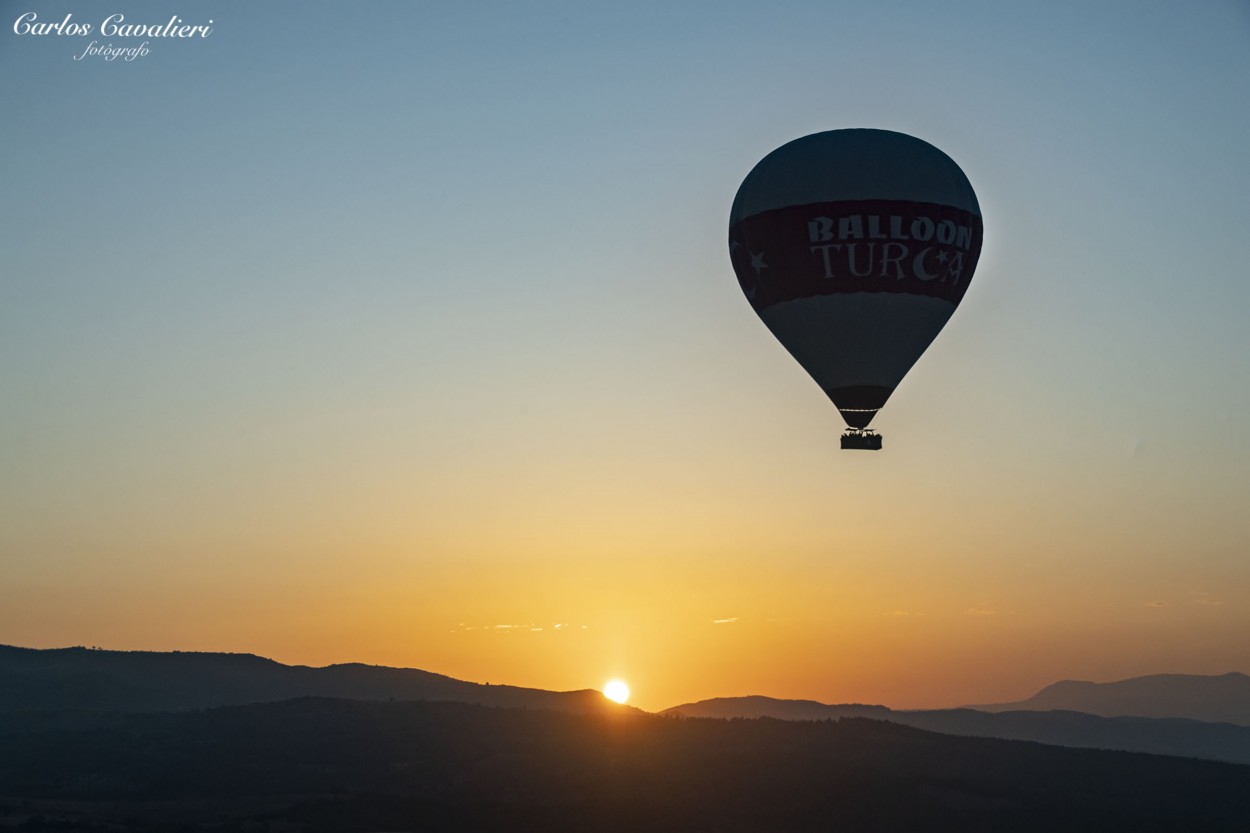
[0,699,1250,833]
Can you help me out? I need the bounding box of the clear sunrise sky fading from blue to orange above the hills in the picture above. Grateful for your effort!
[0,0,1250,709]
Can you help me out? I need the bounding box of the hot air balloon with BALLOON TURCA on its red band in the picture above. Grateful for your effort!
[729,129,981,449]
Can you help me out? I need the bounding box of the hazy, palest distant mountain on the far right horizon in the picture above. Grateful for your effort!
[968,672,1250,727]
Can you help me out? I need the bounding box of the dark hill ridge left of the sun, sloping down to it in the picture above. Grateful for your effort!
[0,645,621,713]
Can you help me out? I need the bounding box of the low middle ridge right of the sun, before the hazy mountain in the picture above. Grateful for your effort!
[664,697,1250,764]
